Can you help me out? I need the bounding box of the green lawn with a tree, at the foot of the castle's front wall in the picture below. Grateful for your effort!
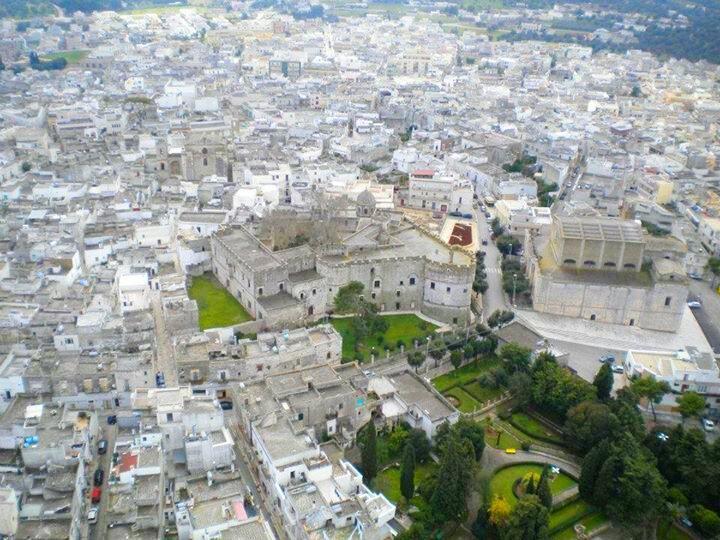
[331,315,437,361]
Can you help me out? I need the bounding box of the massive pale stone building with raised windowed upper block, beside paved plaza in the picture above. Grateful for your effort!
[528,217,687,332]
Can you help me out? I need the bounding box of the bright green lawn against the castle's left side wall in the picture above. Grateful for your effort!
[188,274,252,330]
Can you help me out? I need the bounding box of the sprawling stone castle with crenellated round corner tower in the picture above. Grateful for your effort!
[212,211,475,327]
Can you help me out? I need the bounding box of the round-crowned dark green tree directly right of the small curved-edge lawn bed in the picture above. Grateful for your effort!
[564,401,619,453]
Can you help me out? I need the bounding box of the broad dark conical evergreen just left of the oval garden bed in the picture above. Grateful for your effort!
[430,432,474,523]
